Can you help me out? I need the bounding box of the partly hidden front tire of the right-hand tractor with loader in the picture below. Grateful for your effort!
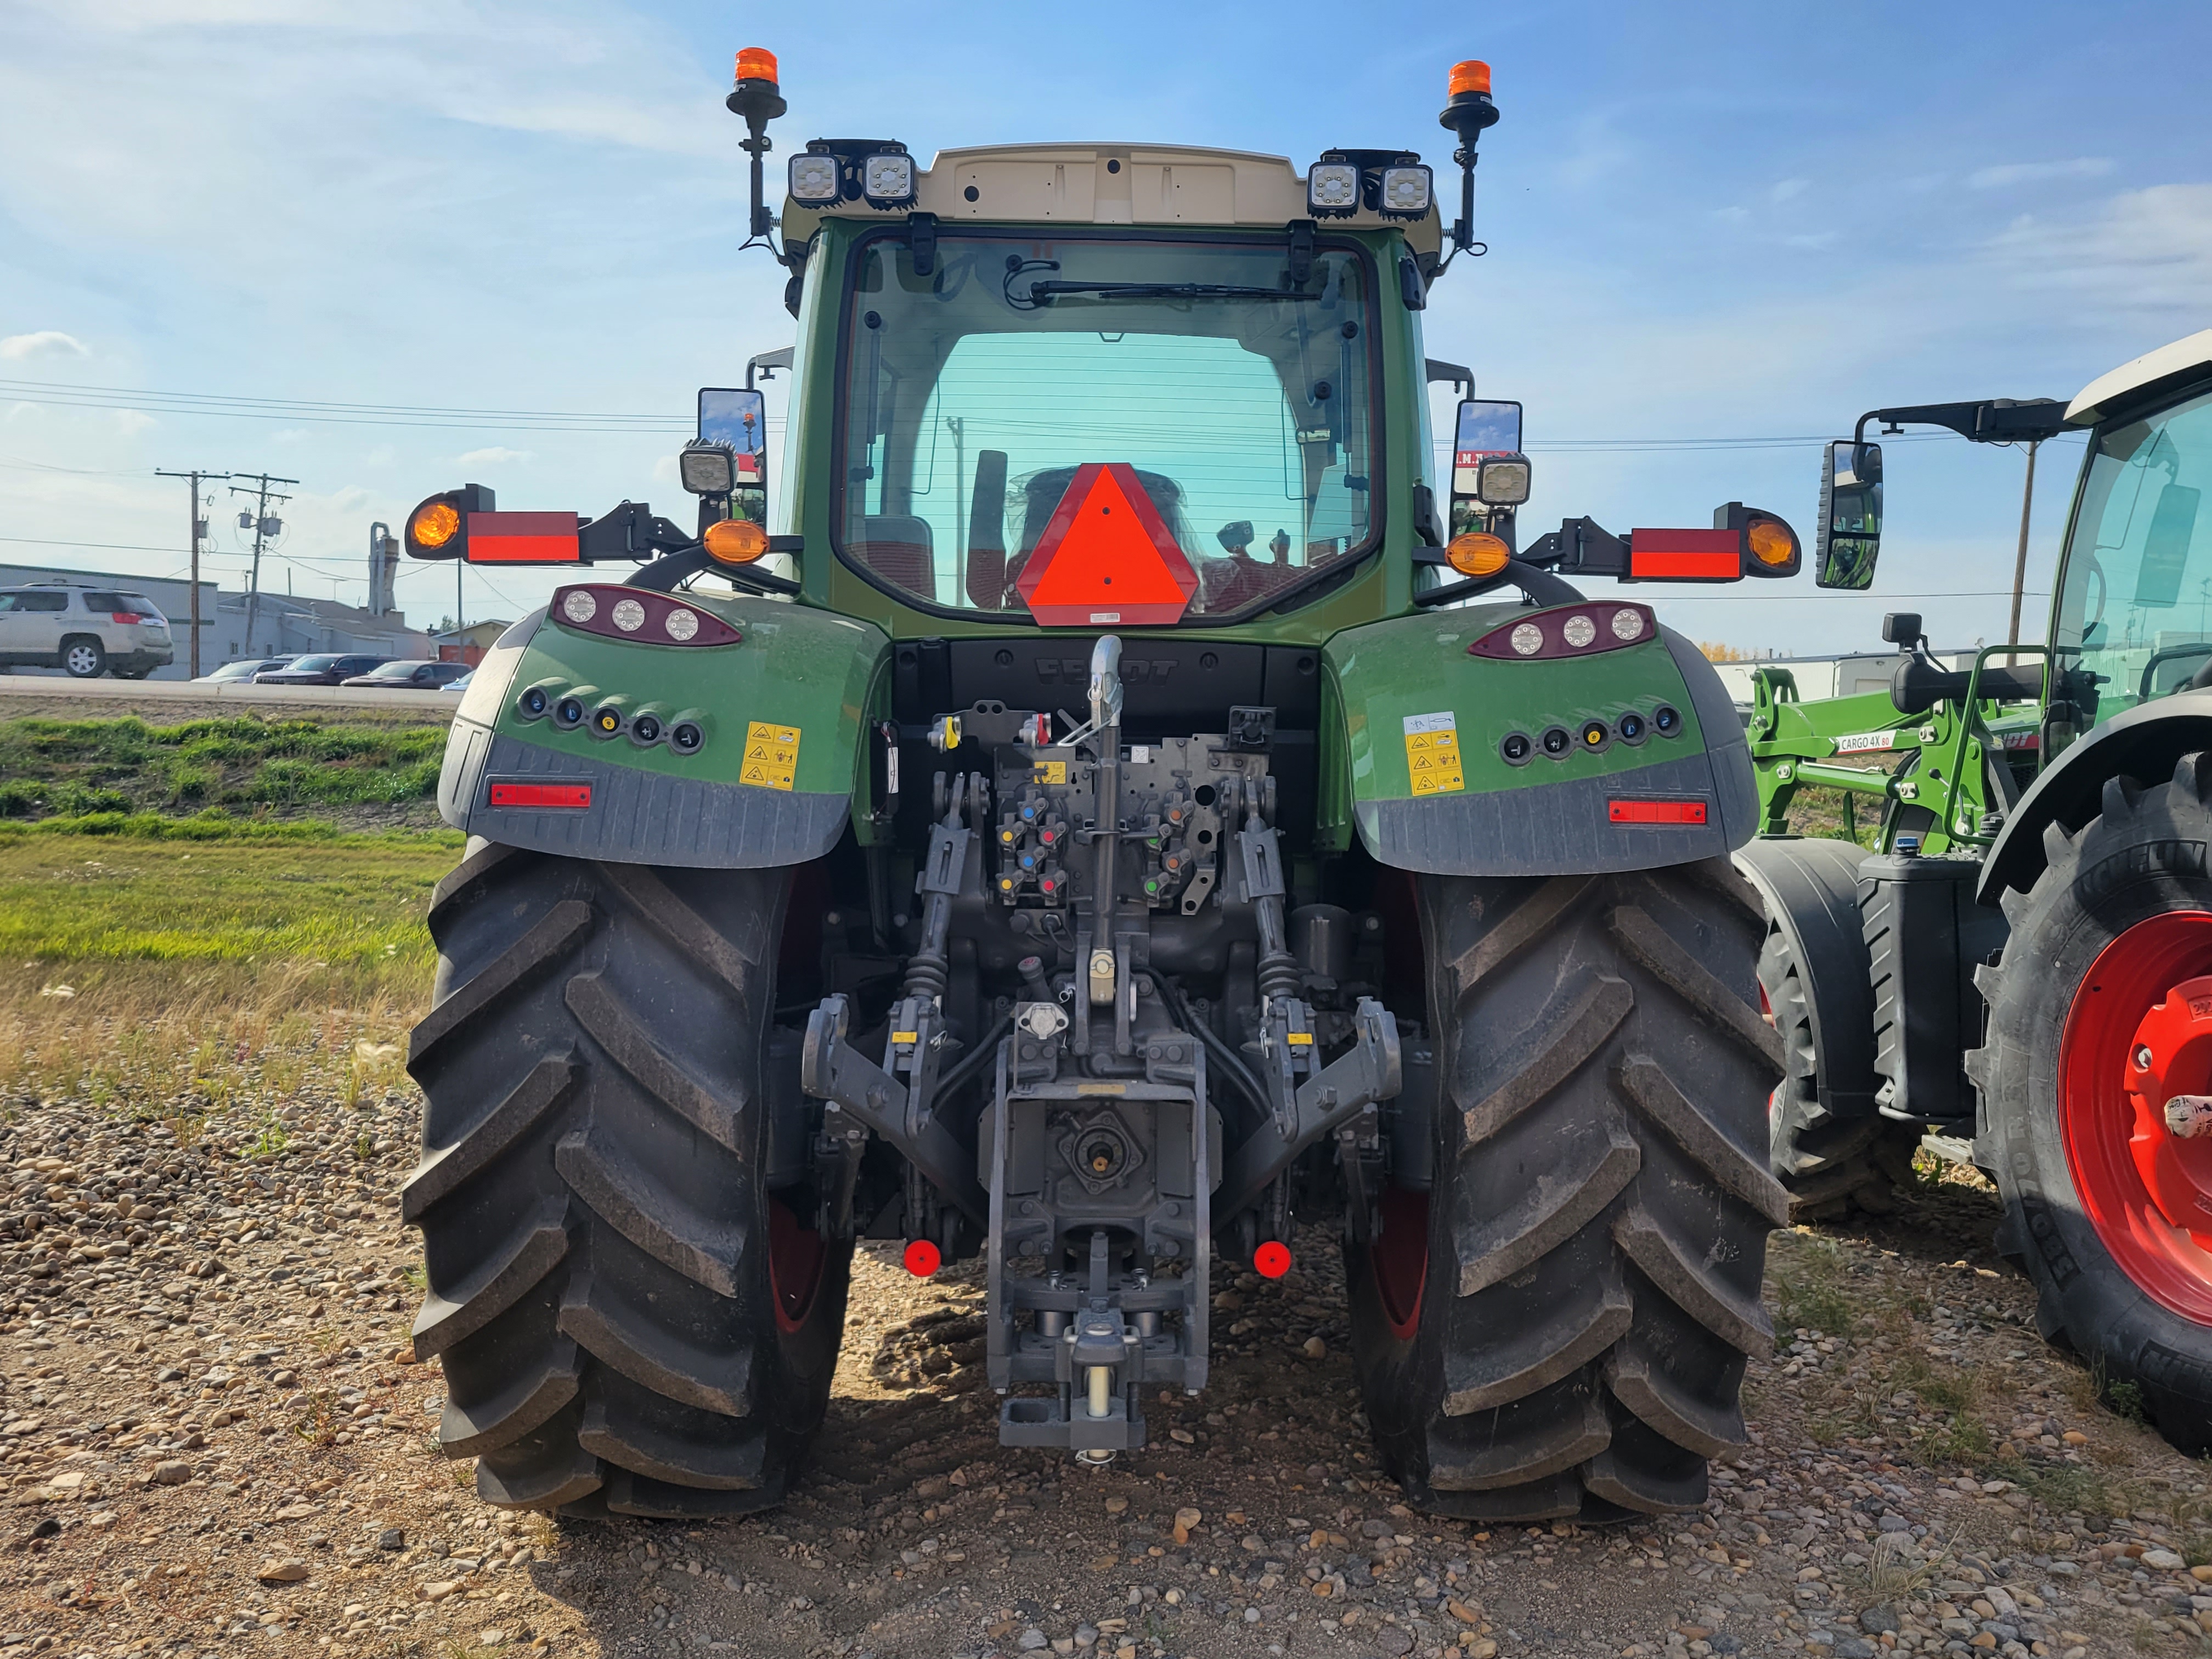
[1758,922,1920,1221]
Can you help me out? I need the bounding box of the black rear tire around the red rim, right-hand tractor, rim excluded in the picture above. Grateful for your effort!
[1982,785,2212,1440]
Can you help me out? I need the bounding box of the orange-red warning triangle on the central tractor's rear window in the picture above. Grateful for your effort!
[1015,460,1199,628]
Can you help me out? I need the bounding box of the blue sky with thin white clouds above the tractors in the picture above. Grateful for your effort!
[0,0,2212,650]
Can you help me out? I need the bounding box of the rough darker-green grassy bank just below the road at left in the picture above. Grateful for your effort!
[0,714,447,819]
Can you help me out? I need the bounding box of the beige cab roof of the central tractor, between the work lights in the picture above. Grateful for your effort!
[783,144,1442,252]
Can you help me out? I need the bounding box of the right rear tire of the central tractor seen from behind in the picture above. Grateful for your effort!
[1347,858,1790,1522]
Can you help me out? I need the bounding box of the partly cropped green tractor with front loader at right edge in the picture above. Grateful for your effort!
[1736,330,2212,1451]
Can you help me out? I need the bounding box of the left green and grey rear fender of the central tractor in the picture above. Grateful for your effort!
[438,593,889,870]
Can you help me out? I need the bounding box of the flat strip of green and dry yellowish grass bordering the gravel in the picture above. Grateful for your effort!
[0,836,460,1124]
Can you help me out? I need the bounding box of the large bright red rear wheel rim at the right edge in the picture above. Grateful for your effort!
[2059,909,2212,1325]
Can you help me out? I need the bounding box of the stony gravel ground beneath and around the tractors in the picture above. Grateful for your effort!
[0,1093,2212,1659]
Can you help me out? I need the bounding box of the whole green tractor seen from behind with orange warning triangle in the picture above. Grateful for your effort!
[405,51,1798,1522]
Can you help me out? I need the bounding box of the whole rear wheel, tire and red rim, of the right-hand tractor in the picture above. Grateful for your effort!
[1966,754,2212,1455]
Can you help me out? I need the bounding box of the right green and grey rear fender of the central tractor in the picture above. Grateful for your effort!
[1318,600,1758,876]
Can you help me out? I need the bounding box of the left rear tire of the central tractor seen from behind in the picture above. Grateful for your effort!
[403,843,851,1517]
